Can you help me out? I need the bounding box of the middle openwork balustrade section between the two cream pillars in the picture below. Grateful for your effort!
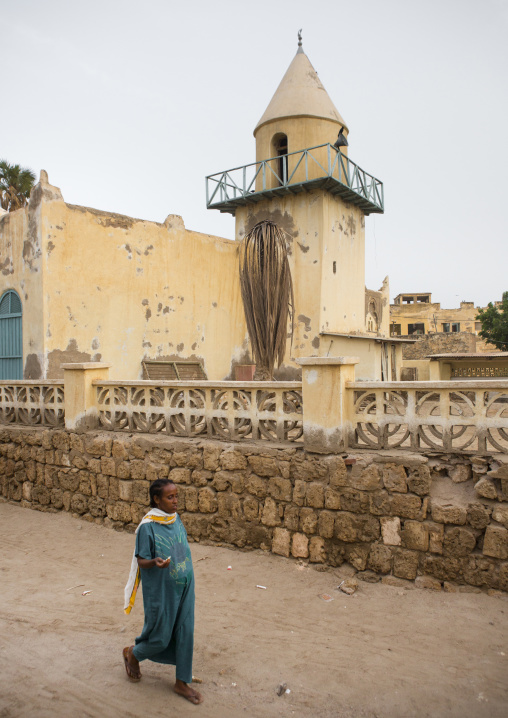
[93,381,303,442]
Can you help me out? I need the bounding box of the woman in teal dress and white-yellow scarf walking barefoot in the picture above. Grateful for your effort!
[123,479,203,705]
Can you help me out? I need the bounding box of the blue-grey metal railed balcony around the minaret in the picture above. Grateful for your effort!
[206,144,384,214]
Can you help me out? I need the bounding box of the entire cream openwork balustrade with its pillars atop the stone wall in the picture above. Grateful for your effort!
[0,372,508,454]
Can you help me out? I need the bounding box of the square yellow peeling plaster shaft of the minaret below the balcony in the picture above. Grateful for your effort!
[236,190,372,372]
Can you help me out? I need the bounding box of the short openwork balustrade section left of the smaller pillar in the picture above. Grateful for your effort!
[0,380,65,427]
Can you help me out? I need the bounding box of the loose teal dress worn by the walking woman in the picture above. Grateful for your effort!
[133,516,194,683]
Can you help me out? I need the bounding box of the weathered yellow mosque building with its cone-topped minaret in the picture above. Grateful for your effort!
[0,41,401,380]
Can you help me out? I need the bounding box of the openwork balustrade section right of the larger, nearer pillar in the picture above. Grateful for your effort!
[346,379,508,453]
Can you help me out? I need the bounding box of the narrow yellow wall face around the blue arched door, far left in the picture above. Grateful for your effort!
[0,201,44,379]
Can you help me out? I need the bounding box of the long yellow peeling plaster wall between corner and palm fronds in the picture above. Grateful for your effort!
[43,202,246,379]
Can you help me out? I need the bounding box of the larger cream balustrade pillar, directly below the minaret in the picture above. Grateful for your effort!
[295,357,360,454]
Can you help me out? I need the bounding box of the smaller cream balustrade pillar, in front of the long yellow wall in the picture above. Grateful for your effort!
[62,362,111,431]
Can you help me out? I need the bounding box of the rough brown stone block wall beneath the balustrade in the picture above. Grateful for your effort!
[0,427,508,591]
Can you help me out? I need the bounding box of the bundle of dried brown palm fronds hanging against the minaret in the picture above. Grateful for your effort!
[240,220,294,381]
